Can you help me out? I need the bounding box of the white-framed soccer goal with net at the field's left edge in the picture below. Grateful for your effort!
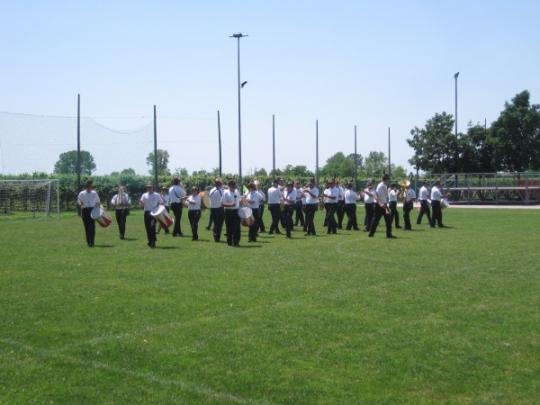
[0,179,60,218]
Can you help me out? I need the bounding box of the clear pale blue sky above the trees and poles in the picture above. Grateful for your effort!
[0,0,540,174]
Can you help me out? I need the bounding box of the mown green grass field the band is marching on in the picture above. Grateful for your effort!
[0,209,540,404]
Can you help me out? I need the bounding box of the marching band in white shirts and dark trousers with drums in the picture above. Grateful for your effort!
[77,174,448,248]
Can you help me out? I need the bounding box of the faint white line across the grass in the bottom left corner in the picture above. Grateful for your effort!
[0,339,268,404]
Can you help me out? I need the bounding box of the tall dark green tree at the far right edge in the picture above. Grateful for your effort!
[489,90,540,171]
